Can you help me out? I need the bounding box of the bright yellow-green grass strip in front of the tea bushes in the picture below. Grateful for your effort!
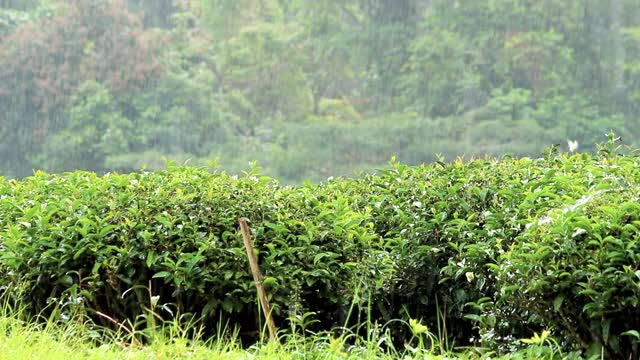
[0,298,579,360]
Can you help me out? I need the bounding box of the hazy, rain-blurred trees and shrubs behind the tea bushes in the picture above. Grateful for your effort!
[0,0,640,183]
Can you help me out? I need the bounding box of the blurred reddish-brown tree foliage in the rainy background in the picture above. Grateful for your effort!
[0,0,159,115]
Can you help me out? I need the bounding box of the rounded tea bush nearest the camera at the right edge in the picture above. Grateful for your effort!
[485,152,640,358]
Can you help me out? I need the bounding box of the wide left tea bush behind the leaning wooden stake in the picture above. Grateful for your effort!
[0,167,392,338]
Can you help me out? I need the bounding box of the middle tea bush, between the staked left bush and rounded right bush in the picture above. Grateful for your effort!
[340,159,555,343]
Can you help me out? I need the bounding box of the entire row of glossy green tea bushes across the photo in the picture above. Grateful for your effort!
[0,147,640,358]
